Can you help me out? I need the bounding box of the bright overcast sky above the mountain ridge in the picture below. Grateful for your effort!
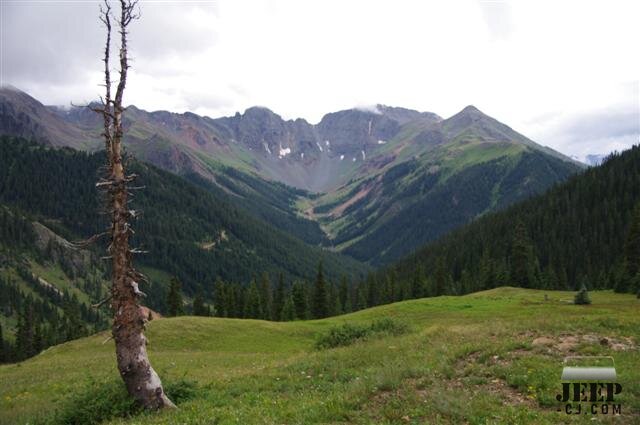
[0,0,640,156]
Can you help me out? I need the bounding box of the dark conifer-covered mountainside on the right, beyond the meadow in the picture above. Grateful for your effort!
[388,146,640,295]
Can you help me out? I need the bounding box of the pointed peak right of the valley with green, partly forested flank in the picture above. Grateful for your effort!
[308,106,581,264]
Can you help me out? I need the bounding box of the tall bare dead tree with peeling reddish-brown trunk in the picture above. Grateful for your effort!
[94,0,175,410]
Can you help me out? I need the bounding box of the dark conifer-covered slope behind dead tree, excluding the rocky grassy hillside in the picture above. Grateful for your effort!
[0,138,365,294]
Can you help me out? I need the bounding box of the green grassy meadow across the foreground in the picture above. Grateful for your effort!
[0,288,640,424]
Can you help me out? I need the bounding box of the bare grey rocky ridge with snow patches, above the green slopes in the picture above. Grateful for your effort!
[0,87,571,192]
